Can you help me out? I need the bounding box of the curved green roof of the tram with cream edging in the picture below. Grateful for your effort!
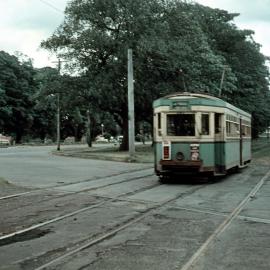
[153,92,251,117]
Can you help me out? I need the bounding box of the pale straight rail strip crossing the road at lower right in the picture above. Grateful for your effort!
[181,170,270,270]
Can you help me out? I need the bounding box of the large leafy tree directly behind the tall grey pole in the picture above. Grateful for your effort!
[42,0,234,148]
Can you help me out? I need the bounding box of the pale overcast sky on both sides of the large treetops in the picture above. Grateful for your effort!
[0,0,270,67]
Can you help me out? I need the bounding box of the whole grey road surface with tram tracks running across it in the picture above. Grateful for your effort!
[0,147,270,270]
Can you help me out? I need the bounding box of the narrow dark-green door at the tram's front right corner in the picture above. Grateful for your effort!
[214,113,225,172]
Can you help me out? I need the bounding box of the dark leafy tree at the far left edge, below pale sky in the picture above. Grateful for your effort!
[0,51,36,143]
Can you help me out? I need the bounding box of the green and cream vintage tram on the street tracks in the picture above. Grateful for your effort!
[153,92,251,180]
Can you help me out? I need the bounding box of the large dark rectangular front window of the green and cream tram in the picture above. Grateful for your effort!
[167,114,195,136]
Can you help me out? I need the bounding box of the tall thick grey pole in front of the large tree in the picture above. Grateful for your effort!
[128,49,135,158]
